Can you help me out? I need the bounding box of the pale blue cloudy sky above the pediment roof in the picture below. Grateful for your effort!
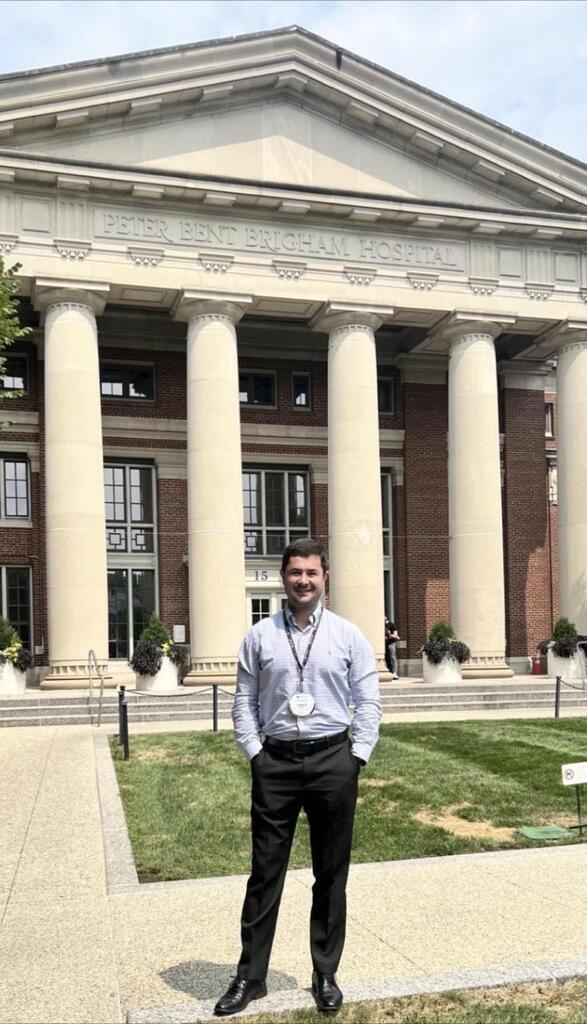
[0,0,587,163]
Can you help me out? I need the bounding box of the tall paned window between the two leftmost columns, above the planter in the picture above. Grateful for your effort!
[104,462,158,658]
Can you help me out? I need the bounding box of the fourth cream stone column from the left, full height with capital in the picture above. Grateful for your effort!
[442,321,512,677]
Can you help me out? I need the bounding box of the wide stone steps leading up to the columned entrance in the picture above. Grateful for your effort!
[0,676,587,729]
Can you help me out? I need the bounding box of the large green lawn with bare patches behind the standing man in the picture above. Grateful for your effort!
[112,719,587,880]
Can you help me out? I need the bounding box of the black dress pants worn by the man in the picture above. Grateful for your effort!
[238,740,360,979]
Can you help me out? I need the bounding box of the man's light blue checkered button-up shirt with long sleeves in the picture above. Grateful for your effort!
[233,605,381,761]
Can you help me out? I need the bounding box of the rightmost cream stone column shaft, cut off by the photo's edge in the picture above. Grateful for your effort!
[556,325,587,634]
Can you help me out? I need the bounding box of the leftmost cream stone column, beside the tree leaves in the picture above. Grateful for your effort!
[35,281,108,688]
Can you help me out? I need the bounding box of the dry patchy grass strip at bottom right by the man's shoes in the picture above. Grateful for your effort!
[235,978,587,1024]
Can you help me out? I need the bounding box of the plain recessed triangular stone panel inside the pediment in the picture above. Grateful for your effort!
[4,97,530,209]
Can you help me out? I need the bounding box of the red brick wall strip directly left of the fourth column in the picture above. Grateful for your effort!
[403,384,449,657]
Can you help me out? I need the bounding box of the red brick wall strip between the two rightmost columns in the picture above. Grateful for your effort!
[503,388,551,657]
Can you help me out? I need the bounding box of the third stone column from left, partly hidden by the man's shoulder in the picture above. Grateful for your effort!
[313,304,390,673]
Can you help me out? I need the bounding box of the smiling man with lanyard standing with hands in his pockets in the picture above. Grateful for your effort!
[214,539,381,1017]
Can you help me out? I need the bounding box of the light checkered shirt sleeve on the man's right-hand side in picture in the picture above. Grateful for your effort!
[349,630,381,762]
